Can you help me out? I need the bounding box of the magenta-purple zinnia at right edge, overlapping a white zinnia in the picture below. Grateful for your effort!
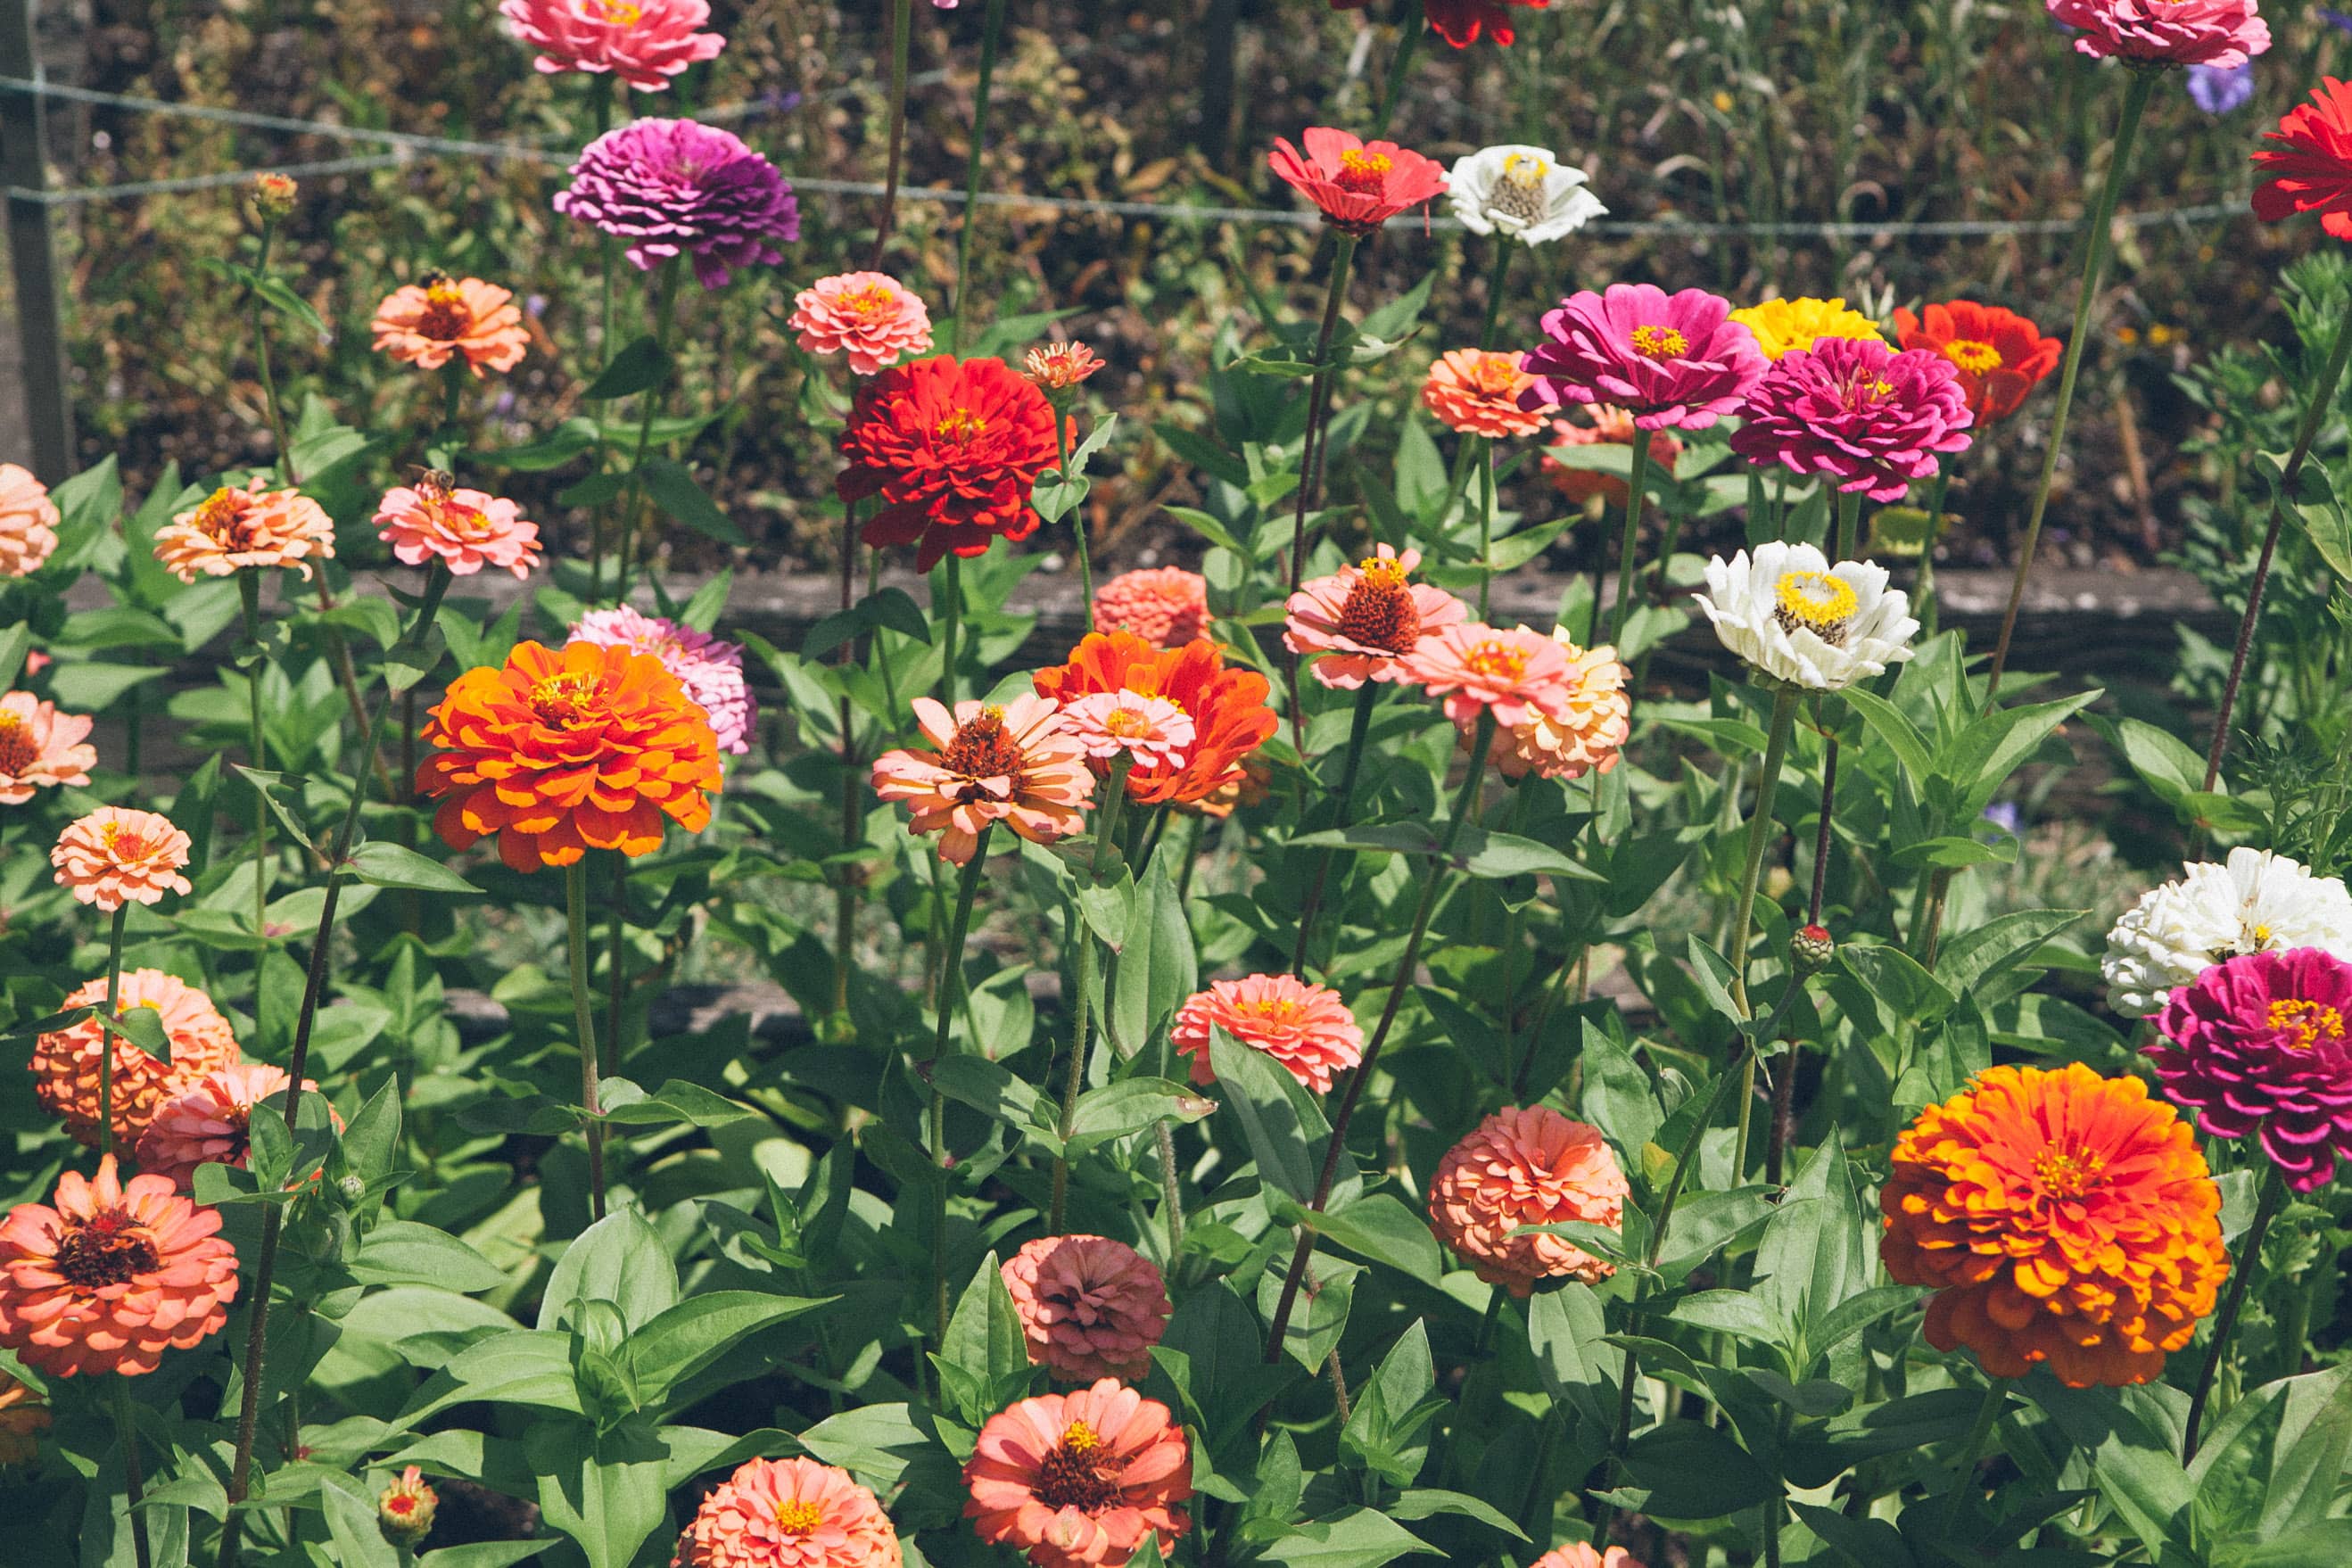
[2148,947,2352,1192]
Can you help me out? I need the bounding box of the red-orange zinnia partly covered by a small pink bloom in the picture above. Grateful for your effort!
[1030,632,1280,806]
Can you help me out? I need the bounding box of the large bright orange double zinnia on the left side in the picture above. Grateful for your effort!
[417,642,720,872]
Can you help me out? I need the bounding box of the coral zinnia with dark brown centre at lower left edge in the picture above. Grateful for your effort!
[0,1154,237,1378]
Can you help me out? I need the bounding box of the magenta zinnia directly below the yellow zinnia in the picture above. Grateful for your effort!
[1731,339,1976,500]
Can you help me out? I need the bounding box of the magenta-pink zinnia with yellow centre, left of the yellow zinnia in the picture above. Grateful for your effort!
[1520,282,1766,430]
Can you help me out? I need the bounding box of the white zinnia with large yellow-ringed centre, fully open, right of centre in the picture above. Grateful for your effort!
[1698,541,1919,691]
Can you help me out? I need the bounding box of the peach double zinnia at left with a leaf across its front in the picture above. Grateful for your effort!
[30,969,237,1147]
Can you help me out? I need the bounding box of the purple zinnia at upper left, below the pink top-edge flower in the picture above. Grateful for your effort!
[555,120,800,289]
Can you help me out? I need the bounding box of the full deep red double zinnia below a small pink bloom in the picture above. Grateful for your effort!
[832,355,1059,571]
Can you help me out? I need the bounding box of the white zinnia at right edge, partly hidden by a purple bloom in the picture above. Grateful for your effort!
[2098,848,2352,1018]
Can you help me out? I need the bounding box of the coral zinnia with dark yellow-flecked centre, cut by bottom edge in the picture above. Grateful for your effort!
[964,1378,1193,1568]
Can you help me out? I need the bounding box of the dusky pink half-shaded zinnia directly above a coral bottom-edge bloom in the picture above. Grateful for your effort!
[1004,1236,1171,1382]
